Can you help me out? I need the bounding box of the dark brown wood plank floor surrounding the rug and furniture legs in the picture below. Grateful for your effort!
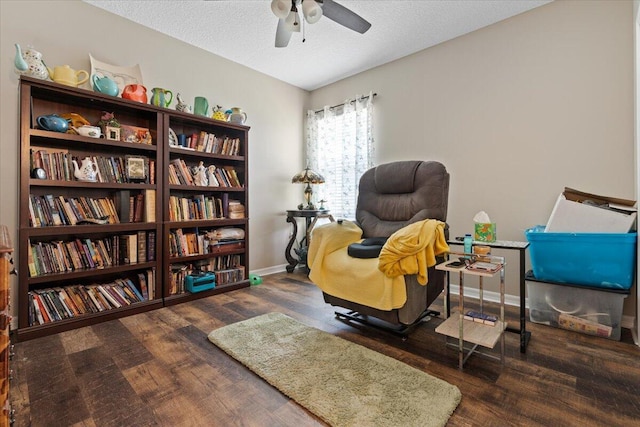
[11,273,640,427]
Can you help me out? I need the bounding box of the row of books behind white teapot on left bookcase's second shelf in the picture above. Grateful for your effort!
[30,148,155,184]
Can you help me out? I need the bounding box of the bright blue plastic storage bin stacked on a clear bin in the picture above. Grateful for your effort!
[525,225,638,289]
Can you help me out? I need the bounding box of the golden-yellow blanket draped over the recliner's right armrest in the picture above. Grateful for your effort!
[378,219,449,285]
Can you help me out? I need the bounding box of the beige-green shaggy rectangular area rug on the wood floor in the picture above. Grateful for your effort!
[209,313,461,427]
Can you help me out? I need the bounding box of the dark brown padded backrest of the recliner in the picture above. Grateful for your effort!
[356,160,449,237]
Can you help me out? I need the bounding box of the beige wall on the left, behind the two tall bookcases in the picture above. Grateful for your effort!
[0,0,309,318]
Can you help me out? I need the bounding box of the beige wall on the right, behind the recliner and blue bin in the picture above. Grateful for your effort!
[311,1,636,315]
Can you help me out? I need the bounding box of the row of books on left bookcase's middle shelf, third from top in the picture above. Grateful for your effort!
[29,194,120,227]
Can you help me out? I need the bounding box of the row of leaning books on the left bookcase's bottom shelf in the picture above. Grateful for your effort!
[28,269,155,326]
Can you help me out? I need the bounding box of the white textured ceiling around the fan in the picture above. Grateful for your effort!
[84,0,550,90]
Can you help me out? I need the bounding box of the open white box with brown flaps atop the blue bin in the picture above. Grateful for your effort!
[546,187,637,233]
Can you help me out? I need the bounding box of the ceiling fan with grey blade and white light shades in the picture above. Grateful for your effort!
[271,0,371,47]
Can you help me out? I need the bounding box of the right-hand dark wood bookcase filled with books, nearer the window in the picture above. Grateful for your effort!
[163,105,249,304]
